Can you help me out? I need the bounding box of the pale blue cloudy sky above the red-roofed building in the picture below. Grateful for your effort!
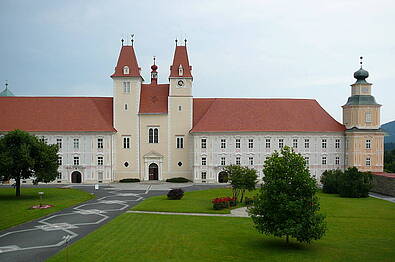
[0,0,395,123]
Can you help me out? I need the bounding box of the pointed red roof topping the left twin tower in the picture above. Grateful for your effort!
[111,46,140,77]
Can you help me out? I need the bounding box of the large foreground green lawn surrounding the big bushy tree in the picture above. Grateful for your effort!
[48,190,395,262]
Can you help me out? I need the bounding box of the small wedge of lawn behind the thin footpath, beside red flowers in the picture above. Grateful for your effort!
[131,188,256,214]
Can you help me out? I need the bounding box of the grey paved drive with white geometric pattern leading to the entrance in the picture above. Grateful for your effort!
[0,184,223,262]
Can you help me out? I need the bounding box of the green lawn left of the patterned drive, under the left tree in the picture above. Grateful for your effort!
[0,187,94,230]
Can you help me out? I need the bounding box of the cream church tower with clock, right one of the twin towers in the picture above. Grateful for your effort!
[168,40,193,180]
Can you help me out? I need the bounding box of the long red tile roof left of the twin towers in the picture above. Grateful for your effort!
[0,97,116,132]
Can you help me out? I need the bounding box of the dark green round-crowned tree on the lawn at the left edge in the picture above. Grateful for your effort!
[0,130,59,197]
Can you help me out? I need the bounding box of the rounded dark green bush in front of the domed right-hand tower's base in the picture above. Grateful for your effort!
[338,167,373,197]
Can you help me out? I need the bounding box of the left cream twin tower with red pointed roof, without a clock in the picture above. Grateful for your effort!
[111,40,143,181]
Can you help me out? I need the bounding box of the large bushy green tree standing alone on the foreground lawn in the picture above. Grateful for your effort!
[249,147,326,243]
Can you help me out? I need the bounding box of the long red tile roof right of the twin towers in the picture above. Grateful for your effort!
[190,98,345,133]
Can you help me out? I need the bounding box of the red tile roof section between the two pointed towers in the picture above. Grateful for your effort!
[139,84,169,114]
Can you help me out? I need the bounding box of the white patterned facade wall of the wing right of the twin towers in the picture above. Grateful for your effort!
[193,132,345,183]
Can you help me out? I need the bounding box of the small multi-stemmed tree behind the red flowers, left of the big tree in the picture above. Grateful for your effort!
[224,165,258,202]
